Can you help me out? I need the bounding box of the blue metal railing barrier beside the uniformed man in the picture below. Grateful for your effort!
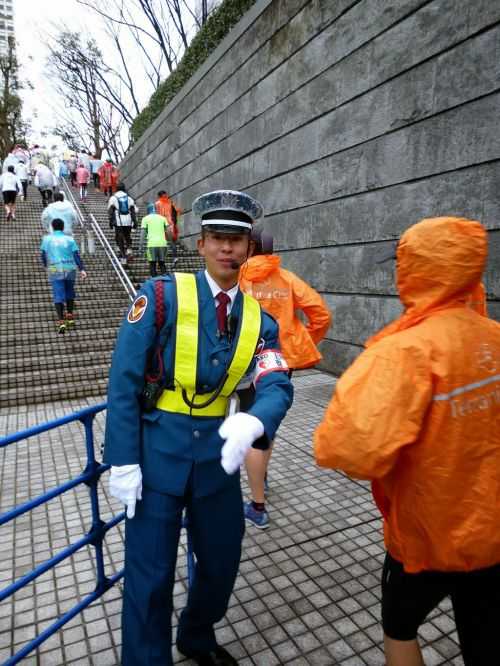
[0,403,119,666]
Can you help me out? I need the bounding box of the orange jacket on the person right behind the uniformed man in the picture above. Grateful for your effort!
[240,254,331,369]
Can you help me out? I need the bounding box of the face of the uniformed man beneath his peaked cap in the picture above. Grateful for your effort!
[198,231,250,289]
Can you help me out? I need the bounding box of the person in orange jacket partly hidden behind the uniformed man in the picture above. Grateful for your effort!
[239,232,331,529]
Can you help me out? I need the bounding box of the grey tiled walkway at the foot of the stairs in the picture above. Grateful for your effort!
[0,371,463,666]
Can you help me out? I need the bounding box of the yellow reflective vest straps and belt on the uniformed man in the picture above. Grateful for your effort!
[156,273,261,416]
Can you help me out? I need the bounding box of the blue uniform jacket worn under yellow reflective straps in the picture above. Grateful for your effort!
[104,272,293,497]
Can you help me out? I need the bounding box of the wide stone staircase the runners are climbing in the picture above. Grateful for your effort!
[0,186,203,408]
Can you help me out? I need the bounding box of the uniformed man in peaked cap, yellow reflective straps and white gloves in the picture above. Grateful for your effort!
[105,190,293,666]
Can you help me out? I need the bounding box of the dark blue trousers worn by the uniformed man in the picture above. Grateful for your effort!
[122,478,245,666]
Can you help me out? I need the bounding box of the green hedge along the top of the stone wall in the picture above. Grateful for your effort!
[130,0,256,141]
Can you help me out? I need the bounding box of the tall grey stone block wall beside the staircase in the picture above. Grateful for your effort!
[122,0,500,372]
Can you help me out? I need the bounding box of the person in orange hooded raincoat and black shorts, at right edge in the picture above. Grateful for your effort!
[314,217,500,666]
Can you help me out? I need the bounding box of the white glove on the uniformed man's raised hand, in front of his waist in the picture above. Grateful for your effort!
[219,412,264,474]
